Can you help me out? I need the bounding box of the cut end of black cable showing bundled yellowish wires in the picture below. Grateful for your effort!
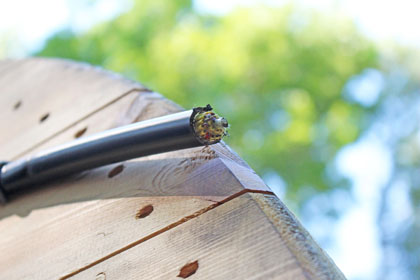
[190,104,229,145]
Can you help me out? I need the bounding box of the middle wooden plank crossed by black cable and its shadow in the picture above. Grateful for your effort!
[0,69,267,279]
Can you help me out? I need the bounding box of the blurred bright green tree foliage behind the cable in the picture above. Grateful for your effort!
[38,0,377,206]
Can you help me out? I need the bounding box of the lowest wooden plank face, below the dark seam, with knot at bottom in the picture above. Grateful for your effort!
[64,194,309,280]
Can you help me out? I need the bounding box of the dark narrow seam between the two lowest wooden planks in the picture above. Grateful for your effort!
[60,189,275,280]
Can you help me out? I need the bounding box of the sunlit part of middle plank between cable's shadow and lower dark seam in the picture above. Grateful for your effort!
[0,197,212,279]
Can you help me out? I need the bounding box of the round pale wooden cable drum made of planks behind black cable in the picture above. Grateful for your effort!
[0,58,344,280]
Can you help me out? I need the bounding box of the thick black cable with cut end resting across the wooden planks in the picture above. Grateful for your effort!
[0,105,228,202]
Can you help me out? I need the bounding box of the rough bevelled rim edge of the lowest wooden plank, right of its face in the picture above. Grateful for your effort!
[251,193,346,279]
